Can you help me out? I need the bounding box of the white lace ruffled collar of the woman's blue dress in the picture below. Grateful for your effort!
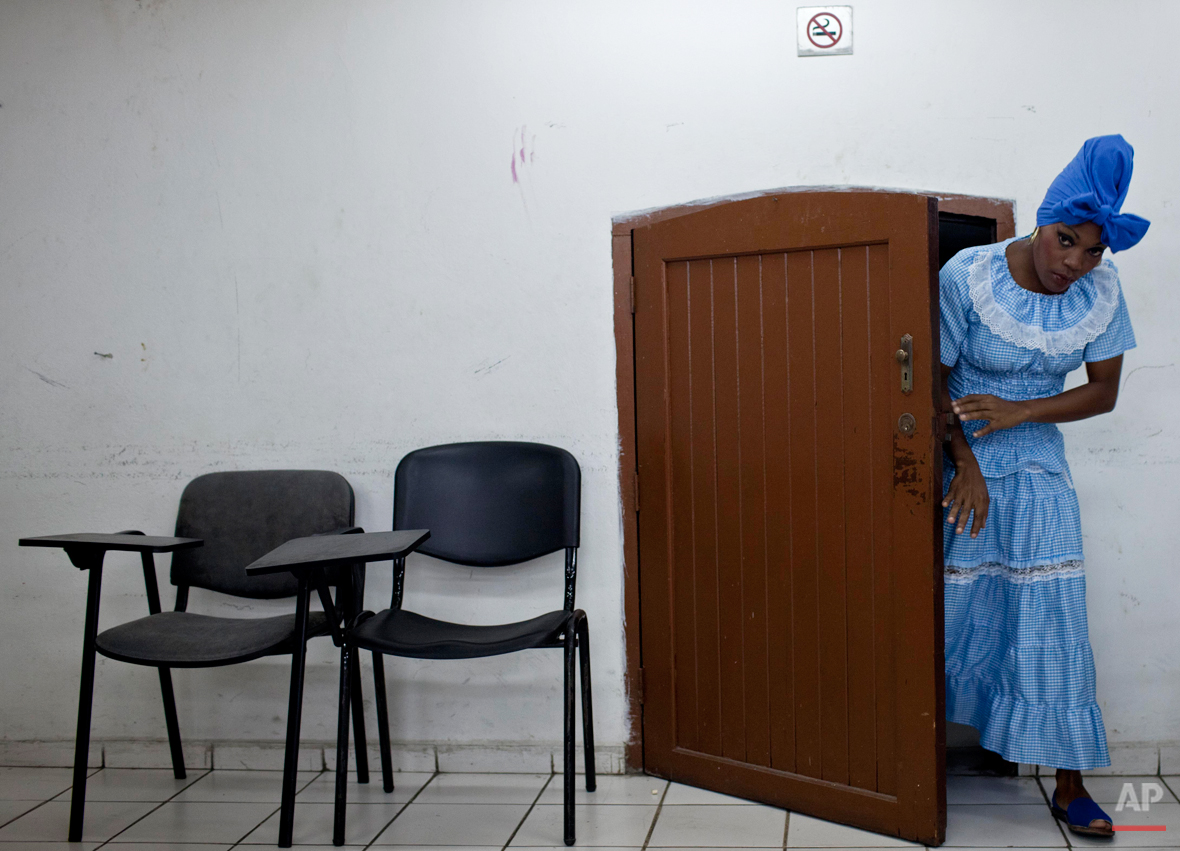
[968,240,1119,354]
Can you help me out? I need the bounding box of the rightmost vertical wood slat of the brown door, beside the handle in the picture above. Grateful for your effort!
[868,240,898,794]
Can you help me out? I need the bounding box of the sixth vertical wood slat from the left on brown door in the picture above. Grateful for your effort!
[787,251,821,778]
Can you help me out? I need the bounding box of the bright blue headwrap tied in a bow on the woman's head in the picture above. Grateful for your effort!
[1036,136,1151,251]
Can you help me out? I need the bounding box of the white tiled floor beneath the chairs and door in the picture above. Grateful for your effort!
[0,768,1180,851]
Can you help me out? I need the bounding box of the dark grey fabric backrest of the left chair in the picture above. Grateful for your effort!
[172,470,354,600]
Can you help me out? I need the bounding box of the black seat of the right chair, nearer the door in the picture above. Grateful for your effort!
[349,609,573,659]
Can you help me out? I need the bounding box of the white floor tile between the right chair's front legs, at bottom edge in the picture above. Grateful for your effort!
[374,801,529,847]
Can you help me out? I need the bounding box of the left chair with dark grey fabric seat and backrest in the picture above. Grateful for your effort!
[79,470,372,847]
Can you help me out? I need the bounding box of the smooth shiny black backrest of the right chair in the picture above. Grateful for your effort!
[393,440,582,568]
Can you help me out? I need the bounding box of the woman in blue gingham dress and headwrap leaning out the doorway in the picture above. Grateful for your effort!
[939,136,1148,836]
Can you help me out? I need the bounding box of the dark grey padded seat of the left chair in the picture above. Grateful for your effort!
[97,611,329,668]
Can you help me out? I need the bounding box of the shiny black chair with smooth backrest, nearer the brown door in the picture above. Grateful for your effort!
[333,443,596,845]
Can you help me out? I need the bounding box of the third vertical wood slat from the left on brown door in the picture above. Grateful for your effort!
[712,257,746,761]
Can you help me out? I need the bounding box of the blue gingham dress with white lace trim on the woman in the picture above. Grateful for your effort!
[939,240,1135,768]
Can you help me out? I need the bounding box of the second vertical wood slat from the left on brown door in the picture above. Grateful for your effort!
[688,260,721,755]
